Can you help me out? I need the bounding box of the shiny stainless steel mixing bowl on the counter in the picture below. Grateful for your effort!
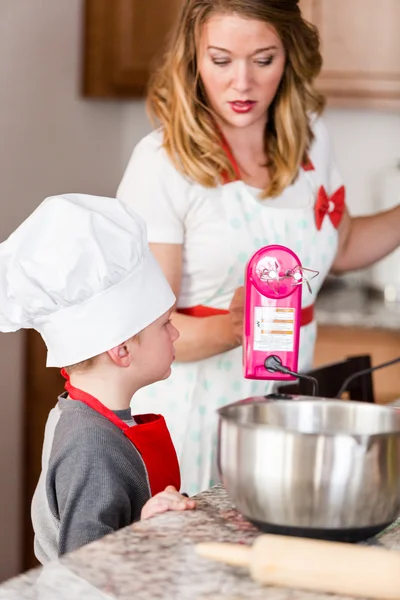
[218,396,400,541]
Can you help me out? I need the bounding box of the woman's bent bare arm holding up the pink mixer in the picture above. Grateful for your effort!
[150,244,241,362]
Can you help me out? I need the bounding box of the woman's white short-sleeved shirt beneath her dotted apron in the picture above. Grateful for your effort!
[117,118,341,308]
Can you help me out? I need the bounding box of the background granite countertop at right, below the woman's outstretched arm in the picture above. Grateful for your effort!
[316,278,400,332]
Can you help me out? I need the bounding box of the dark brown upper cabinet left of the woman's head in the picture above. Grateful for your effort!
[82,0,182,98]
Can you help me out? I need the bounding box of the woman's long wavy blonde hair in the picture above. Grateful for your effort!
[147,0,324,197]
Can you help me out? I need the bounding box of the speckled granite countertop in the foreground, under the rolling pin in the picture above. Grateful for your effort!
[0,486,400,600]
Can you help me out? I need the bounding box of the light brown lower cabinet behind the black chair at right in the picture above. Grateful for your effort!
[314,325,400,404]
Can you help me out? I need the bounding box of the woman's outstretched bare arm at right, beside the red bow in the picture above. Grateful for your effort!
[332,206,400,273]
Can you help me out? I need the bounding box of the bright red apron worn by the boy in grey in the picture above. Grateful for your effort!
[61,369,181,496]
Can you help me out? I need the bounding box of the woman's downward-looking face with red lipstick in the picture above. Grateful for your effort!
[198,14,286,128]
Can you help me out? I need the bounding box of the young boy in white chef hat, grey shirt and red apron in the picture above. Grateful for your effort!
[0,194,194,563]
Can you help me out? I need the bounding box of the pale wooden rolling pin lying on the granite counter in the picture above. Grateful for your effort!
[196,535,400,600]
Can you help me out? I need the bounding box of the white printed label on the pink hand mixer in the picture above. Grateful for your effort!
[254,306,296,352]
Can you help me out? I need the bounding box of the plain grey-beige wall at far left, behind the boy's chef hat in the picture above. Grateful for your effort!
[0,0,124,580]
